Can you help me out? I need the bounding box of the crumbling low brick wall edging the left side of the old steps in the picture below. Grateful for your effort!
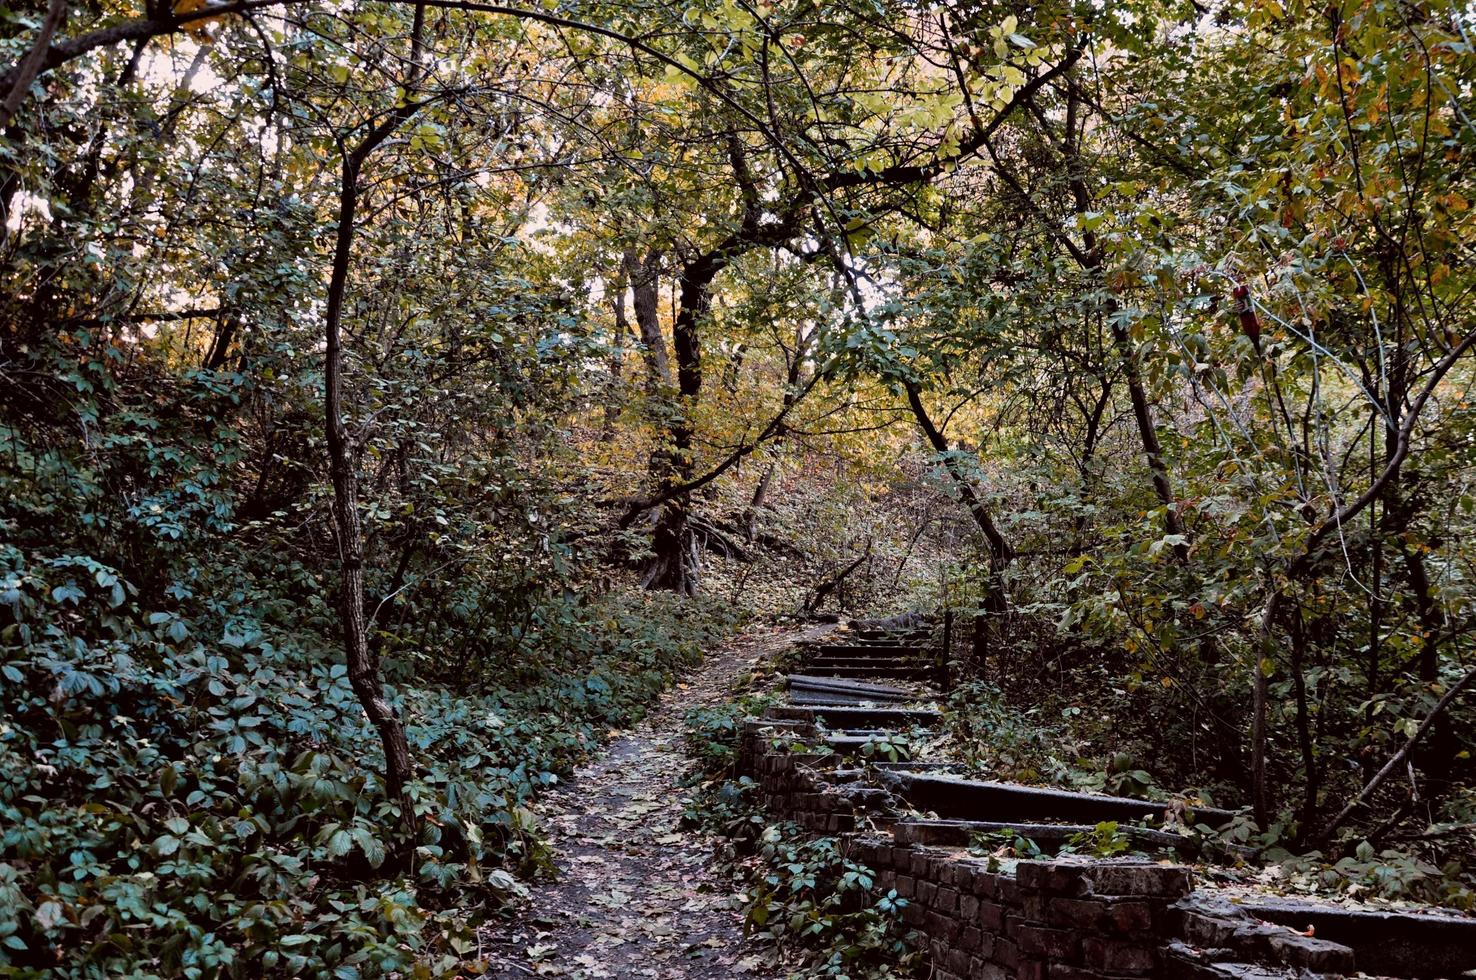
[739,720,1387,980]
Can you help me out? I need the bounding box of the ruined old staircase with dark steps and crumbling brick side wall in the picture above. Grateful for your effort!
[739,619,1476,980]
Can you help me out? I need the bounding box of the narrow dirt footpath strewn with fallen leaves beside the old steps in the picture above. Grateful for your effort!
[483,626,834,980]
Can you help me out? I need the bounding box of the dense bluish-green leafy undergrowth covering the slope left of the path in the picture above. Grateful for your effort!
[0,395,734,977]
